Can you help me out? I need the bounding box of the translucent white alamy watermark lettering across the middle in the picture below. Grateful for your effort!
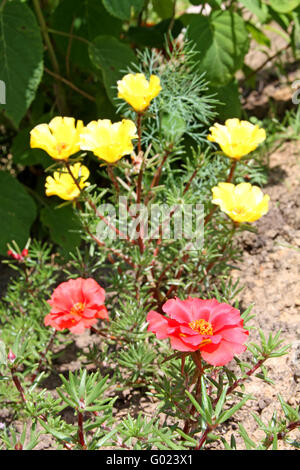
[97,196,204,250]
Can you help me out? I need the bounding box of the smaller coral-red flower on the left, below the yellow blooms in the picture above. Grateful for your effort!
[44,278,108,333]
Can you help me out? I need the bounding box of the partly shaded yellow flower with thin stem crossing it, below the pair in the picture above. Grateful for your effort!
[45,163,90,201]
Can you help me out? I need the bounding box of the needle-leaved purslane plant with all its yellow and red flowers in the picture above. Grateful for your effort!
[2,40,299,450]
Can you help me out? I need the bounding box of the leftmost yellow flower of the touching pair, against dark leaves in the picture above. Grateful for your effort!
[30,116,83,160]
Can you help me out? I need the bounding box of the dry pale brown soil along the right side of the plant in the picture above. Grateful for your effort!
[209,141,300,449]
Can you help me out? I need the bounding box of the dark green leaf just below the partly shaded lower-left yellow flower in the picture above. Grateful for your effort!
[41,205,81,253]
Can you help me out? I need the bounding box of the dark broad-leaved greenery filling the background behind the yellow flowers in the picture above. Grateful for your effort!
[0,0,300,257]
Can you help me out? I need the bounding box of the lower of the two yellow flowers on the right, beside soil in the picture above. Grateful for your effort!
[212,183,270,222]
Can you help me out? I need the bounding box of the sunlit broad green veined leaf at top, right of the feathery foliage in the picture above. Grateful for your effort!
[181,11,249,86]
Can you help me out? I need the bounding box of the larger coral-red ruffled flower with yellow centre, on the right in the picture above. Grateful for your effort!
[147,297,249,366]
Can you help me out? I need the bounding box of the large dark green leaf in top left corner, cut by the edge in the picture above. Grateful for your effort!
[0,2,43,127]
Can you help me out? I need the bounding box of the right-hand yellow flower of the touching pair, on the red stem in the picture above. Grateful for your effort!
[80,119,138,163]
